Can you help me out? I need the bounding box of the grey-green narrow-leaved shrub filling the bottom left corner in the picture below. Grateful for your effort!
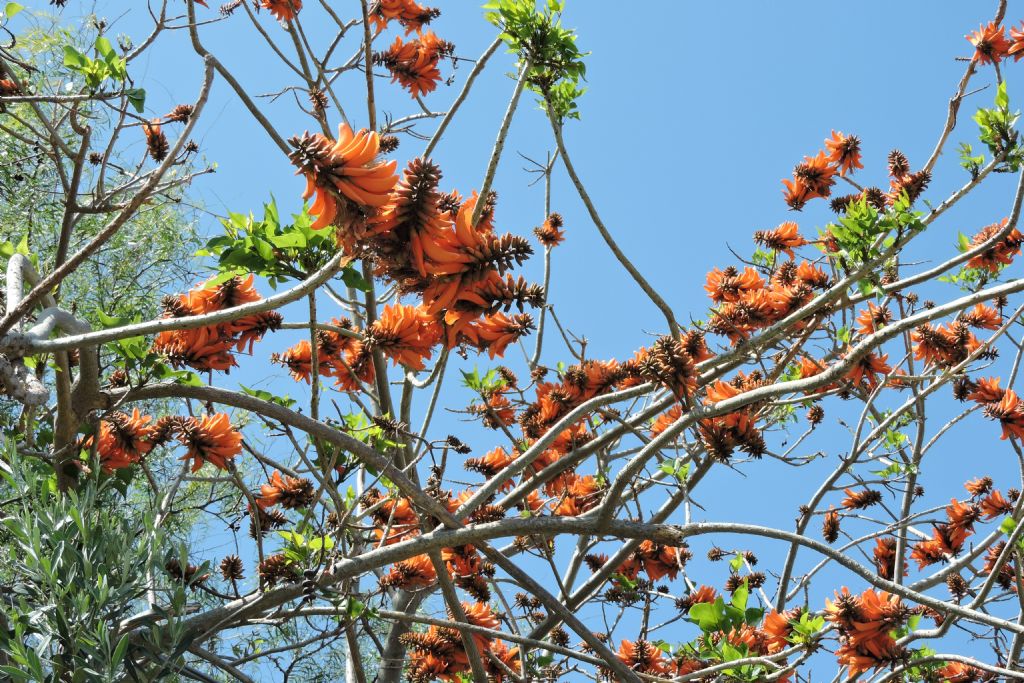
[0,442,184,683]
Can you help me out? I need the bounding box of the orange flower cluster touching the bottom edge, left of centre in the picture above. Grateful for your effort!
[401,602,519,683]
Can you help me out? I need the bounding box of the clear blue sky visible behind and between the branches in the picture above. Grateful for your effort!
[27,0,1024,671]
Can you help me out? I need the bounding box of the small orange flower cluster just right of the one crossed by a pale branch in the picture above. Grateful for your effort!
[270,318,376,391]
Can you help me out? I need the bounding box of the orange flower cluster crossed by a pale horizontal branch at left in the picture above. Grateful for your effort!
[153,274,282,372]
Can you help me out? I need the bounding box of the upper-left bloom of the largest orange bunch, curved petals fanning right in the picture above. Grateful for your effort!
[289,124,398,229]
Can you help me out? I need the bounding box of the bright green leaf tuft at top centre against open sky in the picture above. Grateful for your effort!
[483,0,587,122]
